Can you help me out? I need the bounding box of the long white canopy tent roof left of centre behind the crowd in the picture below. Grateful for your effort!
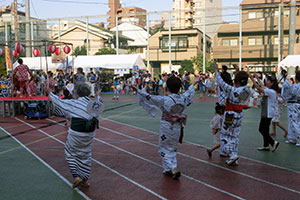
[74,54,146,71]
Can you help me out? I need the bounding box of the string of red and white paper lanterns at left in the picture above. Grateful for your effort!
[0,44,71,57]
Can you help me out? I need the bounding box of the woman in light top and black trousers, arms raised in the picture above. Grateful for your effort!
[250,75,279,152]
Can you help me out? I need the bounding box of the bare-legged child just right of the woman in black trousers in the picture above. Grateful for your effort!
[270,88,288,137]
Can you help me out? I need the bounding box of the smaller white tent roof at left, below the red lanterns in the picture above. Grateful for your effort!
[14,56,64,71]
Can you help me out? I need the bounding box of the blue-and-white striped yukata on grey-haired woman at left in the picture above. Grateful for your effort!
[49,93,100,181]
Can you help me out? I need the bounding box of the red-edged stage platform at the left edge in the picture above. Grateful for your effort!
[0,96,56,117]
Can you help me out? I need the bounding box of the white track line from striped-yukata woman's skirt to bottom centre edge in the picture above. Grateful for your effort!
[15,118,167,200]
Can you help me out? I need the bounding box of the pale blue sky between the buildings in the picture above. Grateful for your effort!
[0,0,242,22]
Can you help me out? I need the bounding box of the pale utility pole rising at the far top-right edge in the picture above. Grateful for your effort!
[289,0,296,55]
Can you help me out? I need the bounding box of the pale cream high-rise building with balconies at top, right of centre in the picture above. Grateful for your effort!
[172,0,222,38]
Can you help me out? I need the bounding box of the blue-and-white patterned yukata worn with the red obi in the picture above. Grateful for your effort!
[215,73,251,159]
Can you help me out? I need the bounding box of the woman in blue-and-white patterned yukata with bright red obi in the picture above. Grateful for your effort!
[214,63,251,166]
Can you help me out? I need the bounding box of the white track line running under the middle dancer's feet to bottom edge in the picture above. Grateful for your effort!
[49,120,244,200]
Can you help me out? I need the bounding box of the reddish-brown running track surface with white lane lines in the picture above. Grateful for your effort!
[1,117,300,200]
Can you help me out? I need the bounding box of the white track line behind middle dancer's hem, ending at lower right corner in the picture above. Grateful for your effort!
[47,119,300,194]
